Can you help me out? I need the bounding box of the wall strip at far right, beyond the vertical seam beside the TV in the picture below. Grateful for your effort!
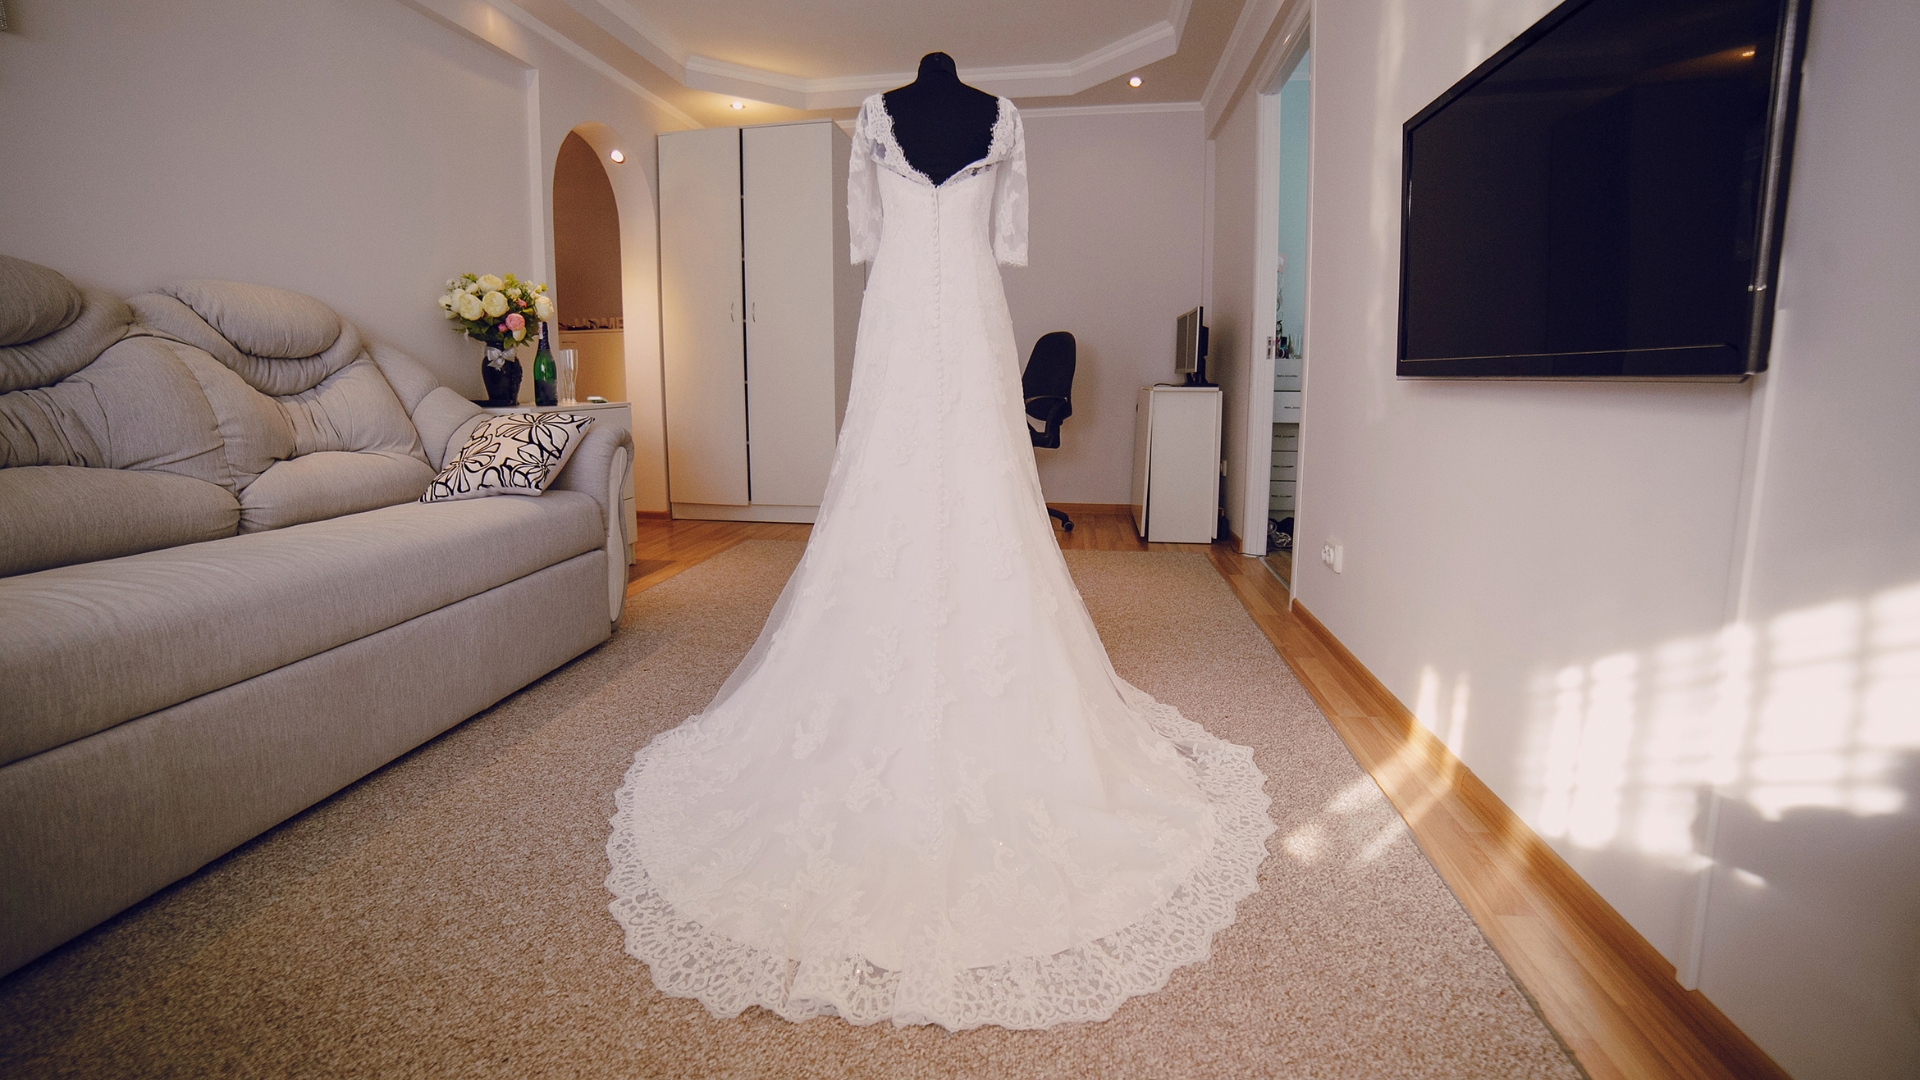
[1701,0,1920,1078]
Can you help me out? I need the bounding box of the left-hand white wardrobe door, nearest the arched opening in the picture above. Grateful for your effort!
[660,127,749,505]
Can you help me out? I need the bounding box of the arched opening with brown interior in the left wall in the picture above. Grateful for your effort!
[553,133,628,402]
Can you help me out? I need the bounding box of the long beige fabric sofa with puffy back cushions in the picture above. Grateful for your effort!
[0,256,632,974]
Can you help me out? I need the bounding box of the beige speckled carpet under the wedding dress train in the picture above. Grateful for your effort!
[0,542,1580,1078]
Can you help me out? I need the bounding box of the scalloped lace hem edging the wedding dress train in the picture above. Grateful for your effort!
[607,694,1275,1030]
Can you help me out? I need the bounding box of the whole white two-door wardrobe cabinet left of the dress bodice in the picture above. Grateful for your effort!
[660,121,864,521]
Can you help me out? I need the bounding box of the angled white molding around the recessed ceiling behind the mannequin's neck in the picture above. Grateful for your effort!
[564,0,1192,111]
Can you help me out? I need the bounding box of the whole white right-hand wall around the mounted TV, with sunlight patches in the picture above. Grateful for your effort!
[1282,0,1920,1078]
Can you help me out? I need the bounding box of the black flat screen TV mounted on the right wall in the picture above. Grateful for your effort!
[1398,0,1809,379]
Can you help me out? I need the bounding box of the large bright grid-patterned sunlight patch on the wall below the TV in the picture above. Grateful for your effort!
[1520,584,1920,867]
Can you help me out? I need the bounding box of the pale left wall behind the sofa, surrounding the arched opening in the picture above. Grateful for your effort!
[0,0,680,507]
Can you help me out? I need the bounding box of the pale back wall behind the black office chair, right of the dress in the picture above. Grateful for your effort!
[1002,110,1206,503]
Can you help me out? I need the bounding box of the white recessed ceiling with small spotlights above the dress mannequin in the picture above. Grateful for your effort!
[495,0,1246,123]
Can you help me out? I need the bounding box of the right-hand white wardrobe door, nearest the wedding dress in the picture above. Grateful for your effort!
[741,123,845,507]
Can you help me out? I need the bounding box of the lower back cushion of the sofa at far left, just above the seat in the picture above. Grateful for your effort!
[0,465,240,577]
